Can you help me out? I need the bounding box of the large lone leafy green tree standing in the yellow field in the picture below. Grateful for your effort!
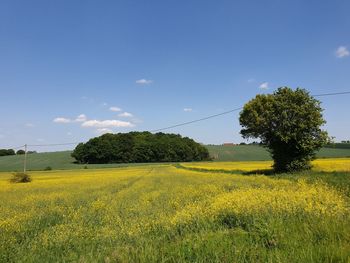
[239,87,328,172]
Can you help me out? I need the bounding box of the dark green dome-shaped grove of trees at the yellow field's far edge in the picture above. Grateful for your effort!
[72,132,209,163]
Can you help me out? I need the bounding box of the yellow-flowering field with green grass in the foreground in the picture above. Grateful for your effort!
[0,162,350,262]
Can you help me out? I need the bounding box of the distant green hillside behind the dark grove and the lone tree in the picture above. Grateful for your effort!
[0,145,350,171]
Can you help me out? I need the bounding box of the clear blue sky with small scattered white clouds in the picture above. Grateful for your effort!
[0,0,350,150]
